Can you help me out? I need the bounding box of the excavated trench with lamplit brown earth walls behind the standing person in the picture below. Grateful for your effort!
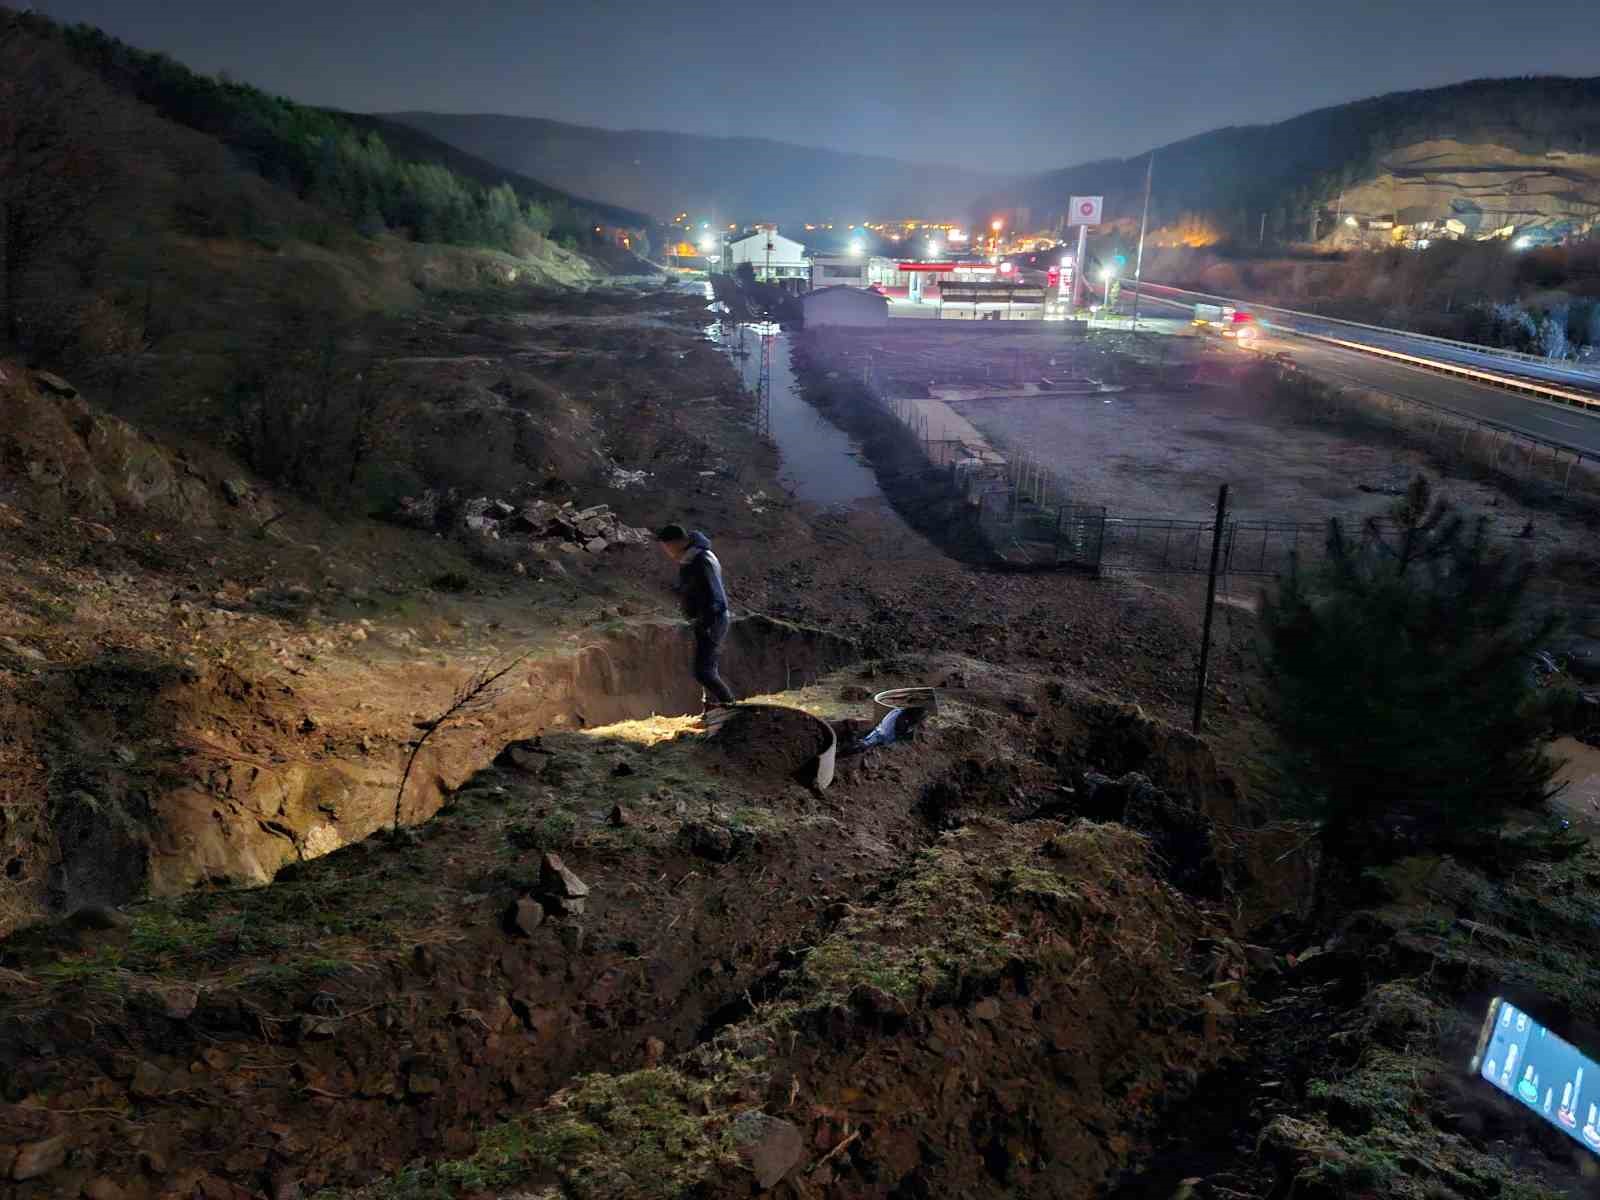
[21,616,856,933]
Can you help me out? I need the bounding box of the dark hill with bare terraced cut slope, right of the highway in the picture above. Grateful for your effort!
[973,77,1600,242]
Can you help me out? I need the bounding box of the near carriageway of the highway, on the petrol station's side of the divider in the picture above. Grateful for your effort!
[1122,285,1600,458]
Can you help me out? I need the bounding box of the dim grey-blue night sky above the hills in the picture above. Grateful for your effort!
[31,0,1600,170]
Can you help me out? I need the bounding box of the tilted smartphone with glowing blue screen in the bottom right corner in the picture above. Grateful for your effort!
[1472,997,1600,1154]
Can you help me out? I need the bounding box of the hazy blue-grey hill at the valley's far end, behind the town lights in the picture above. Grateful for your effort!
[387,112,1002,226]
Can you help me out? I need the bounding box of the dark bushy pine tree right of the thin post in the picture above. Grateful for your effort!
[1262,477,1555,866]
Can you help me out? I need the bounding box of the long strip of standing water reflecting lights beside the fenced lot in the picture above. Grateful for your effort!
[707,322,882,506]
